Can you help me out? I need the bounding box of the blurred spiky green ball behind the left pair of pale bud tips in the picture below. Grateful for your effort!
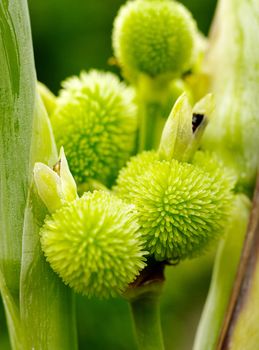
[51,71,137,186]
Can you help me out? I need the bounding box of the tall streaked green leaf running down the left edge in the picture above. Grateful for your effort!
[0,0,36,304]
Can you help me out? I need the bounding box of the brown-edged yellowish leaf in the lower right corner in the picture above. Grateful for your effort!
[220,176,259,350]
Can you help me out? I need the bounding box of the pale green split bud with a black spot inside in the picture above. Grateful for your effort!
[158,94,214,161]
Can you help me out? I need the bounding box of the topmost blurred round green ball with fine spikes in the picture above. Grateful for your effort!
[113,0,196,79]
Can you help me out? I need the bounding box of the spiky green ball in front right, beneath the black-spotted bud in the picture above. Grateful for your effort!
[115,152,233,260]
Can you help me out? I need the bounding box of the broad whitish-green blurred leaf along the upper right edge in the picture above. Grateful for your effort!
[203,0,259,192]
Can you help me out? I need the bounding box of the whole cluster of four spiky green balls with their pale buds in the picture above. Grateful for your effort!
[34,0,256,304]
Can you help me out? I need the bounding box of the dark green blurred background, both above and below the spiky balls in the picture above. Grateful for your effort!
[0,0,216,350]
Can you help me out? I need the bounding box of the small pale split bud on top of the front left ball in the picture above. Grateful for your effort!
[33,148,77,213]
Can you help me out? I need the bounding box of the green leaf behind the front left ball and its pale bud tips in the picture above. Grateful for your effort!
[20,98,77,350]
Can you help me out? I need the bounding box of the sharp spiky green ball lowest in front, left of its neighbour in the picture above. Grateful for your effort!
[41,191,145,297]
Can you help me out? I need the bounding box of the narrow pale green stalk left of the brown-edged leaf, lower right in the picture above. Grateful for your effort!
[193,195,251,350]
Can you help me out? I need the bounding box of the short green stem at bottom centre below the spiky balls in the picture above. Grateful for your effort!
[130,291,164,350]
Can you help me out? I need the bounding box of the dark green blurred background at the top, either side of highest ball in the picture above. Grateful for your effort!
[29,0,216,93]
